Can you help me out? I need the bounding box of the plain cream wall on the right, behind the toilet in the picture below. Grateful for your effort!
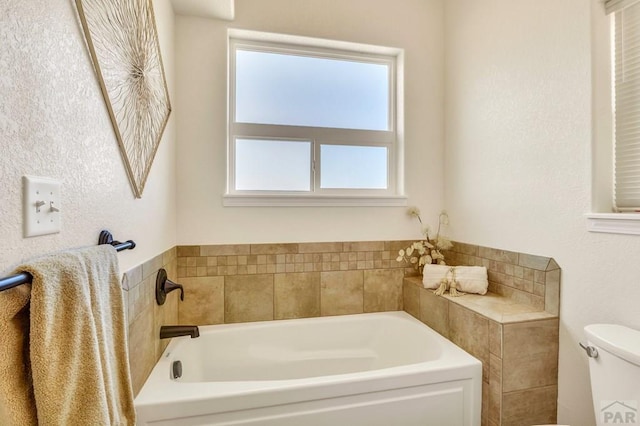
[444,0,640,426]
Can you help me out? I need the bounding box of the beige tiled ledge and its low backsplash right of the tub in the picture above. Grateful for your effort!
[403,243,561,426]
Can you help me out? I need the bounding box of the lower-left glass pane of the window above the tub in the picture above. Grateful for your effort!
[235,139,311,191]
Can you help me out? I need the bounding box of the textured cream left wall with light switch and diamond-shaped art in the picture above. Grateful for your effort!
[0,0,176,276]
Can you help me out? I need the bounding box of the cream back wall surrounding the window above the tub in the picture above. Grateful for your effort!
[176,0,443,245]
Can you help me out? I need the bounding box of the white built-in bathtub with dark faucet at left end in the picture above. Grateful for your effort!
[135,312,482,426]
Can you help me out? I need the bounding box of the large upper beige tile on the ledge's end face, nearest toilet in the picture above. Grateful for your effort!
[502,319,558,392]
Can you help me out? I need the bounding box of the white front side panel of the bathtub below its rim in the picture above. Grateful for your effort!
[138,380,480,426]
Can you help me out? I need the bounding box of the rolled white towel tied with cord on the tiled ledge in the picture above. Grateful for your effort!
[422,265,489,295]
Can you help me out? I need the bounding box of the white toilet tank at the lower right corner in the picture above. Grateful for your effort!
[584,324,640,426]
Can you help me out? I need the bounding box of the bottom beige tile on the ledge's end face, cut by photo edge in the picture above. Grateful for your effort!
[502,386,556,426]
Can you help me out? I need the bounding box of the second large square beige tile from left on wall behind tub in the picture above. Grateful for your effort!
[224,274,273,323]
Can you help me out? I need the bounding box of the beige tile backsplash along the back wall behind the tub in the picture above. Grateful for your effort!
[172,241,415,325]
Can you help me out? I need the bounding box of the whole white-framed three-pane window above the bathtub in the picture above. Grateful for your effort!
[224,30,405,205]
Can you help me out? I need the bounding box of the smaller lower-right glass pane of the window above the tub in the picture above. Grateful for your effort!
[320,145,388,189]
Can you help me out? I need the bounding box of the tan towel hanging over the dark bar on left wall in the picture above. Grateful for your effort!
[0,245,135,426]
